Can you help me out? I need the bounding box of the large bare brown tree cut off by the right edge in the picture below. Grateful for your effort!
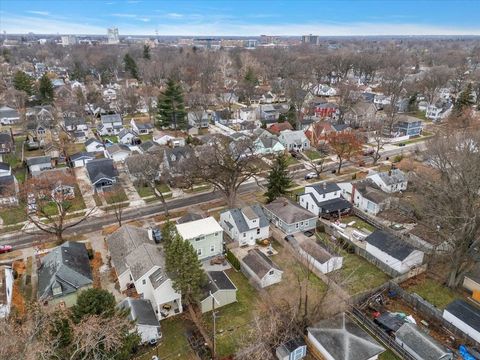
[415,130,480,288]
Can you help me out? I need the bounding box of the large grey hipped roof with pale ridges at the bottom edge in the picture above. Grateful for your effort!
[308,313,385,360]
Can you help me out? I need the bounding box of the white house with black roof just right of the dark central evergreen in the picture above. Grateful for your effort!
[299,182,352,217]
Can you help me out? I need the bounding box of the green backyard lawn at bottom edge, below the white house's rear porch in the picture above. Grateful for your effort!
[138,315,194,360]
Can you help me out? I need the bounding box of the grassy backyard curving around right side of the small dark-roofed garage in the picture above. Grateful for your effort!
[203,269,257,358]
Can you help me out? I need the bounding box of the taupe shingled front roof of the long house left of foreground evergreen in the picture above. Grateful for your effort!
[106,225,165,280]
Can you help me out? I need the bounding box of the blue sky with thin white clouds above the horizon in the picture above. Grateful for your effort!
[0,0,480,36]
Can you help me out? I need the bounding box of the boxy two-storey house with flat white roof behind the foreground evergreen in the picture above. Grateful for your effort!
[176,216,223,260]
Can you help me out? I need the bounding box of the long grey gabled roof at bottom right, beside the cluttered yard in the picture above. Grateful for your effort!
[395,323,449,360]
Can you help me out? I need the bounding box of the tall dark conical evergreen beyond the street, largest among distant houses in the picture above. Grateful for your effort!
[157,79,187,130]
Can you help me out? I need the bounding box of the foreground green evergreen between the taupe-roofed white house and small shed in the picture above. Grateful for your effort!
[165,226,206,304]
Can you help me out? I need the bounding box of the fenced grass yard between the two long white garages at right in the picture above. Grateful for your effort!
[329,250,390,295]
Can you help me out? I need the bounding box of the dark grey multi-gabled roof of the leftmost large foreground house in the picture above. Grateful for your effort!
[38,241,93,298]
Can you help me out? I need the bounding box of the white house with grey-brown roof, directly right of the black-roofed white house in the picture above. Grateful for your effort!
[338,179,390,215]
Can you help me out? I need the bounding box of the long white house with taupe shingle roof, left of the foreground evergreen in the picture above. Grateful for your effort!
[106,225,183,320]
